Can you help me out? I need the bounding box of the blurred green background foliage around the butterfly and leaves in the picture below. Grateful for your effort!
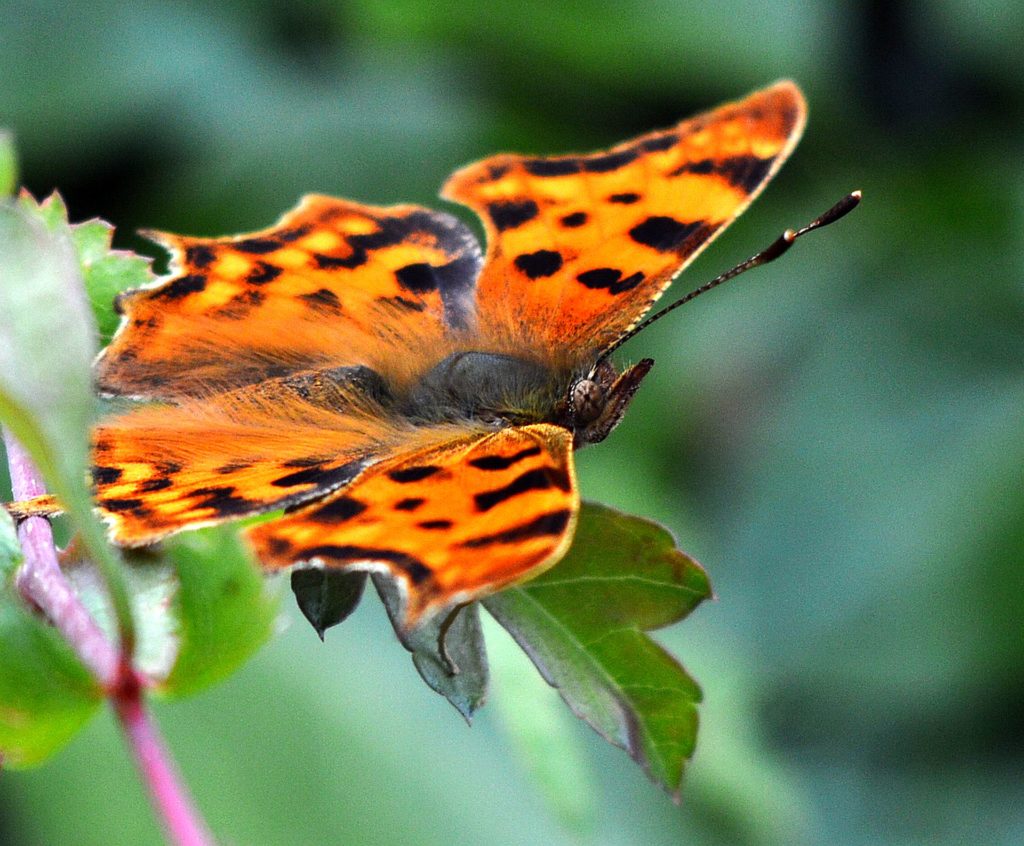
[0,0,1024,846]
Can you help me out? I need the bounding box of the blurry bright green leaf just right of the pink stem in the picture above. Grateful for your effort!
[160,526,280,695]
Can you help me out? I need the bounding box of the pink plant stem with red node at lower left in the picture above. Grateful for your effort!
[3,428,214,846]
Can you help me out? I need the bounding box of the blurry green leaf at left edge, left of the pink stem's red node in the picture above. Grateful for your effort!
[0,509,102,767]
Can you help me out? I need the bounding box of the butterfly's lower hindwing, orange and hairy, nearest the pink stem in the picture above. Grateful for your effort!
[92,369,411,546]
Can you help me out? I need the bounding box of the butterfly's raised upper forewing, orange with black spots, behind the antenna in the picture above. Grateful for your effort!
[442,82,806,361]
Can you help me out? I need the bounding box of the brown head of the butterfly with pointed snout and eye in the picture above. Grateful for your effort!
[565,358,654,449]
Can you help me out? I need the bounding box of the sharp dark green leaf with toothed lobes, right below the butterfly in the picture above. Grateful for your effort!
[483,504,711,795]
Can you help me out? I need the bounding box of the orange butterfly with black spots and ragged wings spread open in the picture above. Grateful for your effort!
[37,81,806,625]
